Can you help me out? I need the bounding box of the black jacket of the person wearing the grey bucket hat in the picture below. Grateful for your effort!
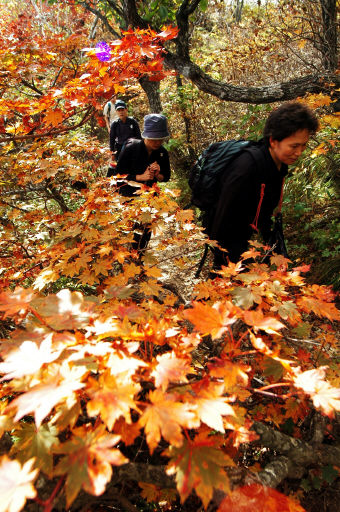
[107,140,170,196]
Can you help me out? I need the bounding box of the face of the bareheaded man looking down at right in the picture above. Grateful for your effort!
[269,129,310,165]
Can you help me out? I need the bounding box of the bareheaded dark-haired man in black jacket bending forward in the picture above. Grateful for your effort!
[207,102,319,270]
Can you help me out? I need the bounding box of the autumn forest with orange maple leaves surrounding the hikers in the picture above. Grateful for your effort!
[0,0,340,512]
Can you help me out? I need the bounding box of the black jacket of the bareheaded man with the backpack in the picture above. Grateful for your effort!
[207,143,288,262]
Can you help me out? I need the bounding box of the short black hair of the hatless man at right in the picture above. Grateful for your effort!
[263,101,319,145]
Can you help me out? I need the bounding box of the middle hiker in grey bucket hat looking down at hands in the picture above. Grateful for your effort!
[107,114,170,251]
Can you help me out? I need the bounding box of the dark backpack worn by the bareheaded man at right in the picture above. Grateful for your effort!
[189,140,257,211]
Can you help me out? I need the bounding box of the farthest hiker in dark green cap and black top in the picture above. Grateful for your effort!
[110,100,141,162]
